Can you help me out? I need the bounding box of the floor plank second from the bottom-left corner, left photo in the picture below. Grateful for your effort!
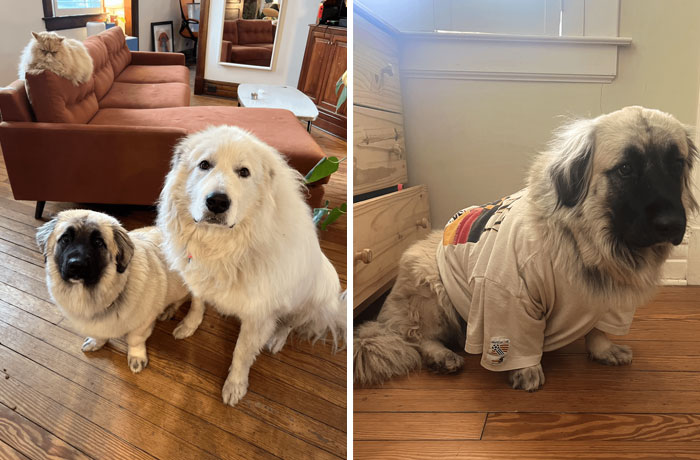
[0,372,154,460]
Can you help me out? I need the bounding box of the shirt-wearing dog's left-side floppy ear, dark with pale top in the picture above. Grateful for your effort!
[549,120,595,208]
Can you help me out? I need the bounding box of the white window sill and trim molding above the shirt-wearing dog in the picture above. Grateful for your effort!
[400,32,632,83]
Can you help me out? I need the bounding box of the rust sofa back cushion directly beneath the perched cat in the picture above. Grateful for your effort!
[25,70,98,123]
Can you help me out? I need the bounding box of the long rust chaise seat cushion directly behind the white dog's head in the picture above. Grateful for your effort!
[90,106,328,177]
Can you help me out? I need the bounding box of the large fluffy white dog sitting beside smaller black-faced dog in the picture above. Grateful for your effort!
[158,126,345,406]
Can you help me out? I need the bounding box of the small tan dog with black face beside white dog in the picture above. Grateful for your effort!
[36,209,204,373]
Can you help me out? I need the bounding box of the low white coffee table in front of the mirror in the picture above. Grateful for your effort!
[238,83,318,131]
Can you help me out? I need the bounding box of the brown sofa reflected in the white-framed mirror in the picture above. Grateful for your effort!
[220,0,283,69]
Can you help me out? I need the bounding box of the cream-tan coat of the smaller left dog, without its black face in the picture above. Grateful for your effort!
[37,210,203,373]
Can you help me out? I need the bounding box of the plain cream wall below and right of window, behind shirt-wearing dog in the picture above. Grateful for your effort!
[402,0,700,227]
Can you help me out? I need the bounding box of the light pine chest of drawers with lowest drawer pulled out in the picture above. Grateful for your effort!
[353,10,431,315]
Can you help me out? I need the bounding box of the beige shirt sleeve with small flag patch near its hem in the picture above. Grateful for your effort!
[474,279,546,371]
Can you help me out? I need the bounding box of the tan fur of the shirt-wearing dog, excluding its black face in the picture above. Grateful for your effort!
[354,107,697,391]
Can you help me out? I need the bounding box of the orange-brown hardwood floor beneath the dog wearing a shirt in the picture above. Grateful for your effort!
[353,287,700,460]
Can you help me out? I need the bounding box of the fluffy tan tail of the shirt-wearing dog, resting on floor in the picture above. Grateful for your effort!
[353,321,421,385]
